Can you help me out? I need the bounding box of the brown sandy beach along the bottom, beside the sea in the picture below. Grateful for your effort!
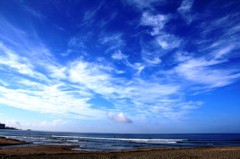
[0,138,240,159]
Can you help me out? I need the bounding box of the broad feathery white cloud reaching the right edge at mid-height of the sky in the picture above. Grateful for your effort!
[175,55,240,88]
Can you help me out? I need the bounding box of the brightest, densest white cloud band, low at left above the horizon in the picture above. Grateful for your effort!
[0,85,99,117]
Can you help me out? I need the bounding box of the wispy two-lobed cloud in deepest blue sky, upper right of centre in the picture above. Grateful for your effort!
[140,11,182,67]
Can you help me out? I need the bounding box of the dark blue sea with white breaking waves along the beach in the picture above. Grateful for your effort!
[0,130,240,151]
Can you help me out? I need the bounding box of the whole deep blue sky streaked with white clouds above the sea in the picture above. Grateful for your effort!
[0,0,240,133]
